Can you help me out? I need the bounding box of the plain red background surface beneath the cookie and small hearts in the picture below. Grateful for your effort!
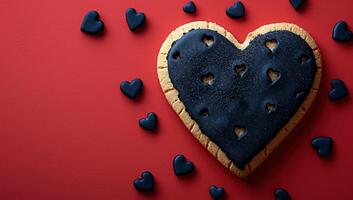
[0,0,353,200]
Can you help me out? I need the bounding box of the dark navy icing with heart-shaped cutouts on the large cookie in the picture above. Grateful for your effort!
[167,29,317,169]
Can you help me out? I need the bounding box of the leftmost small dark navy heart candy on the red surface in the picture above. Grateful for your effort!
[81,10,104,35]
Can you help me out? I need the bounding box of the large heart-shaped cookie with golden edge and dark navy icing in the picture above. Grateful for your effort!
[157,22,322,177]
